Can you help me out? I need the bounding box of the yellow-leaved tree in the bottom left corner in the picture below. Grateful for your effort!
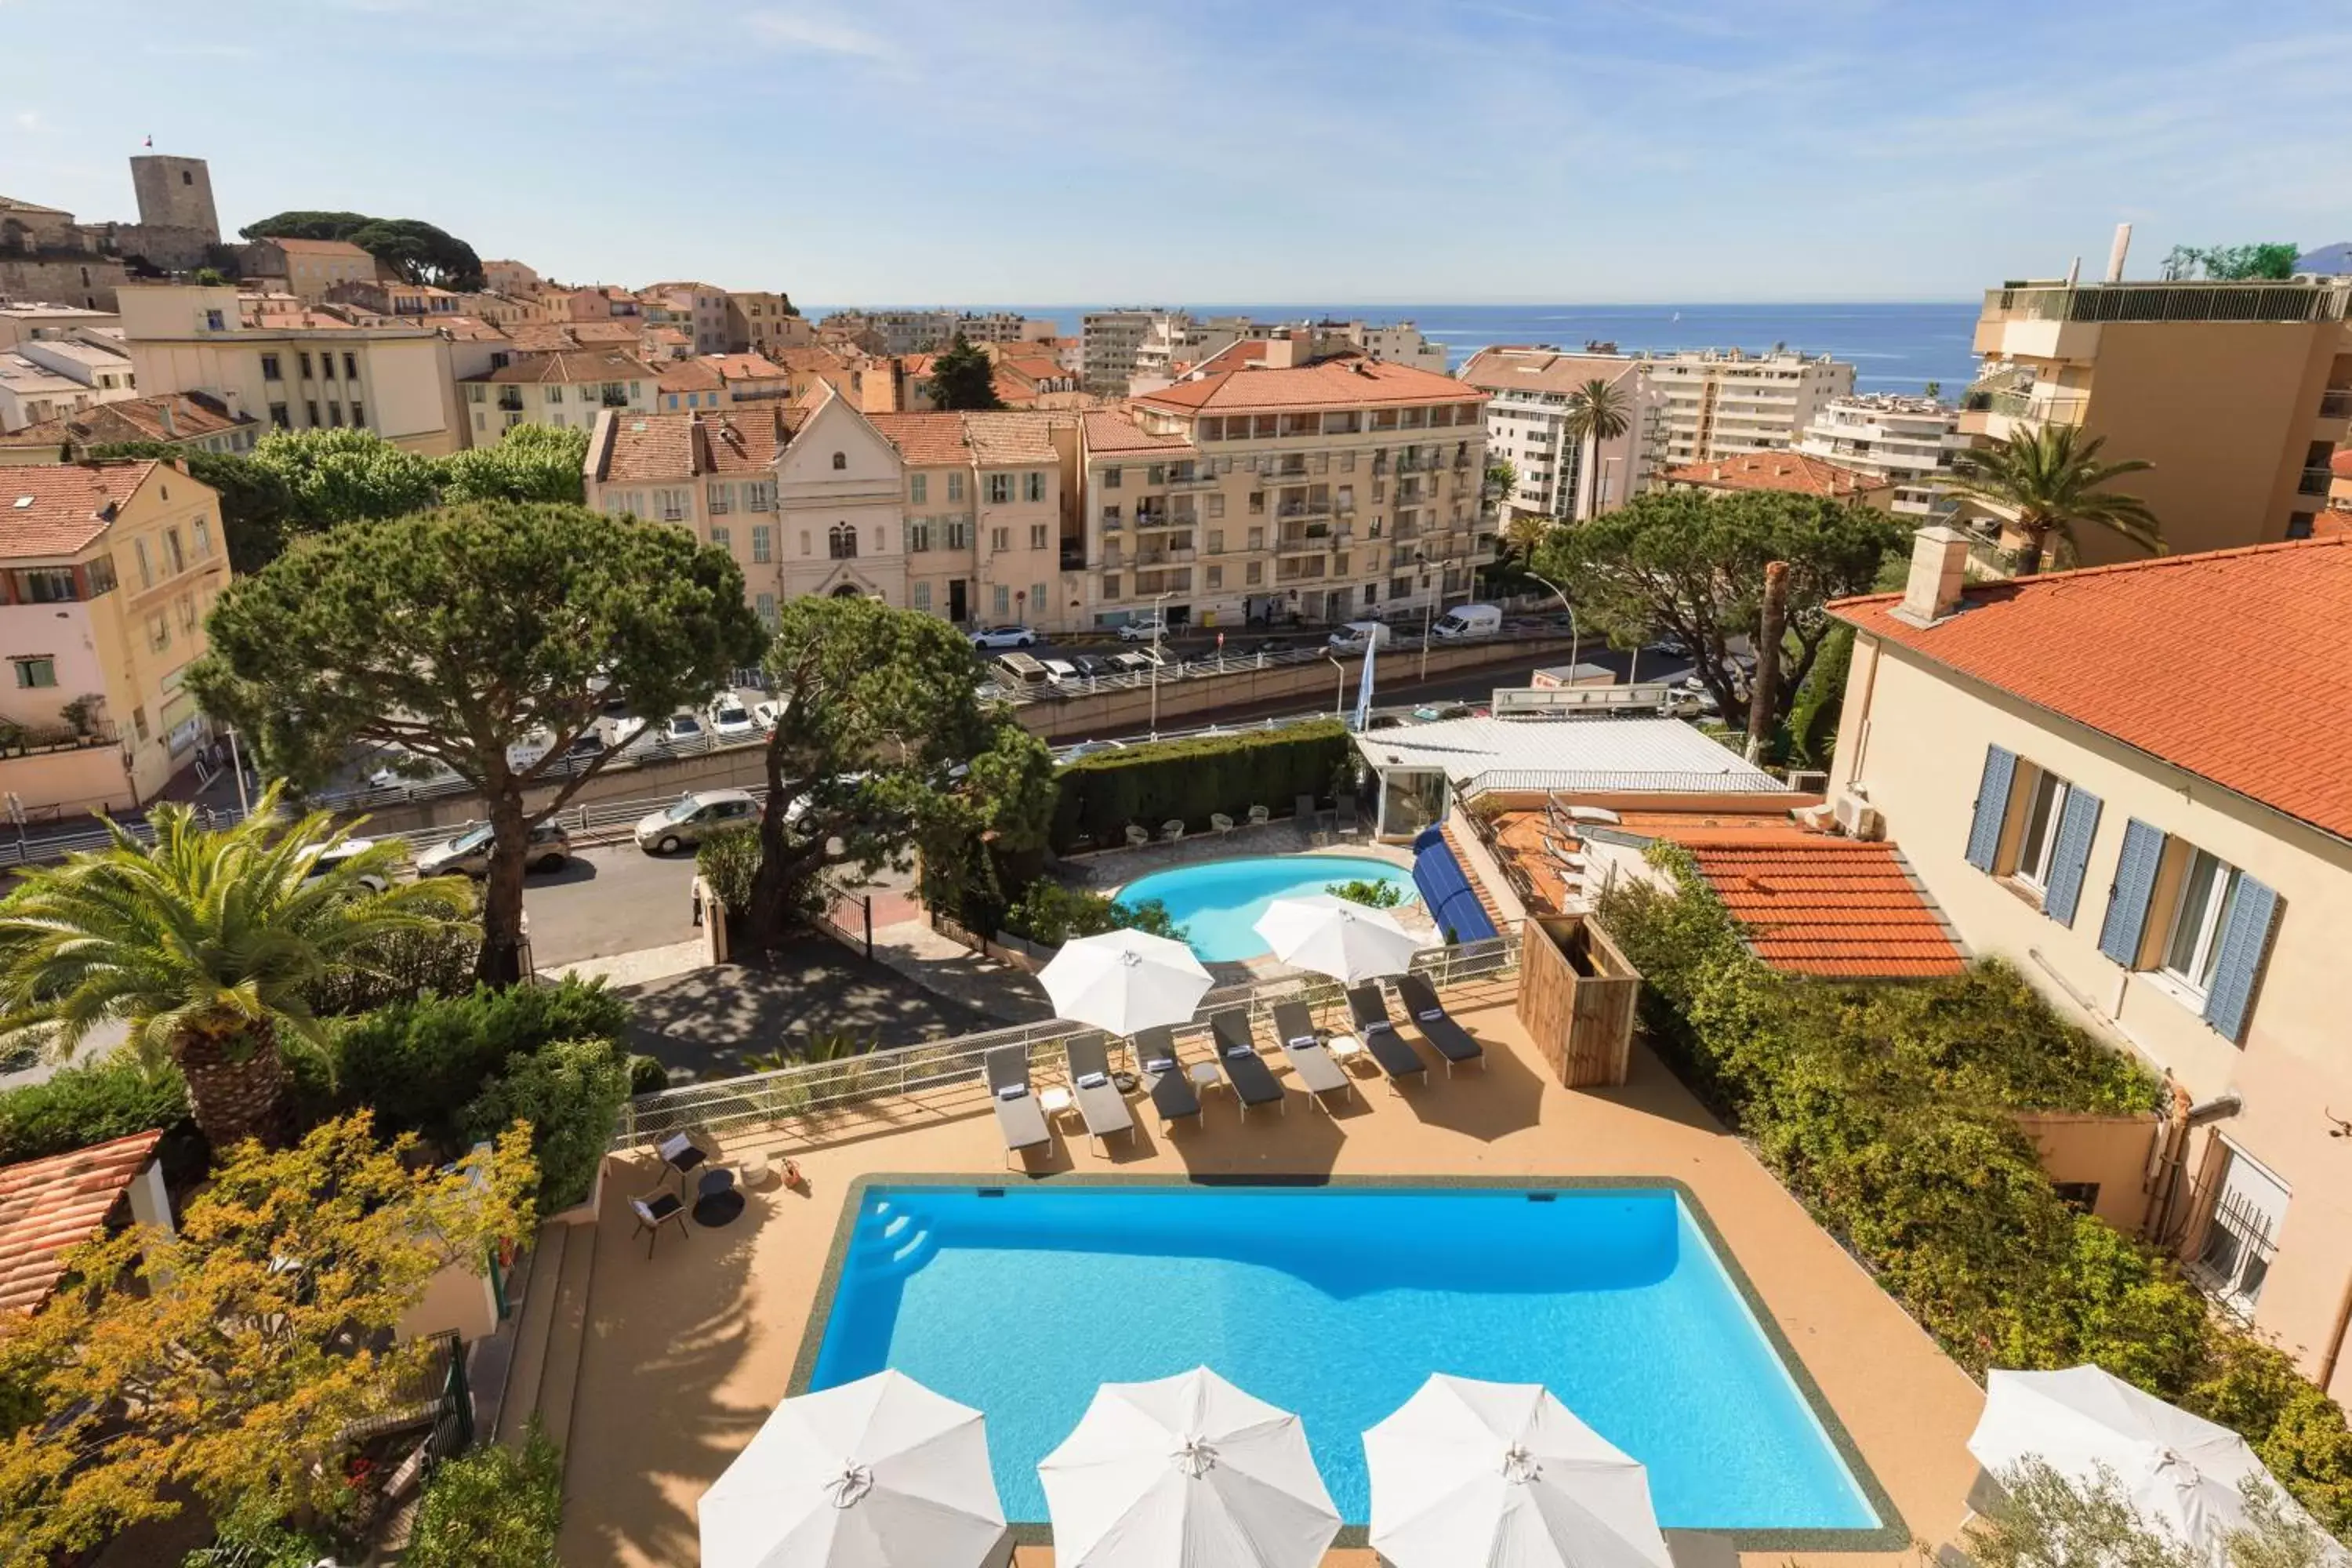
[0,1112,534,1568]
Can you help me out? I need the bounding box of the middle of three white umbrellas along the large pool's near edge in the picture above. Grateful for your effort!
[1037,1366,1338,1568]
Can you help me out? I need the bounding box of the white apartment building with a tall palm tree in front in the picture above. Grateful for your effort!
[1461,346,1665,522]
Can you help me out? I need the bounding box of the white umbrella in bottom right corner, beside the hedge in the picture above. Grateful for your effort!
[1969,1366,2333,1563]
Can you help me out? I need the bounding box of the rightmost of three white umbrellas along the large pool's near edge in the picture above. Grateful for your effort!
[1364,1373,1672,1568]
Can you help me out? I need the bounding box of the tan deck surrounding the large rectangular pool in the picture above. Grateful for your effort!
[560,982,1983,1568]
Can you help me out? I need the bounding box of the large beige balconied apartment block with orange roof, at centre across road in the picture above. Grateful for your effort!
[1096,359,1494,626]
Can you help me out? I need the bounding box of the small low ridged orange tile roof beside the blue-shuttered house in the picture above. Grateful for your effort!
[1693,841,1966,980]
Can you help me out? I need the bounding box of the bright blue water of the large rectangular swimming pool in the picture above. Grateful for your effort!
[811,1185,1879,1530]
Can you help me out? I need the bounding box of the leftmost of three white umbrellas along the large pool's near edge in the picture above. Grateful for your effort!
[694,1370,1004,1568]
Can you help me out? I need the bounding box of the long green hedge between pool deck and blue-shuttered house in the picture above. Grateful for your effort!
[1599,846,2352,1535]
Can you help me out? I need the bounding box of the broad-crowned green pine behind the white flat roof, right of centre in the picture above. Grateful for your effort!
[1536,489,1903,727]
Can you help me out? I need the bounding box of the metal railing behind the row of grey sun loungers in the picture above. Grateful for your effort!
[612,935,1519,1154]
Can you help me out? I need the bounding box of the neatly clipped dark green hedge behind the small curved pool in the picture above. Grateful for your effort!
[1051,720,1350,853]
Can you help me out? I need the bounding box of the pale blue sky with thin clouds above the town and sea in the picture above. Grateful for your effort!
[0,0,2352,303]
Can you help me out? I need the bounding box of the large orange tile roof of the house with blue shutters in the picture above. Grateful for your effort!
[1830,536,2352,839]
